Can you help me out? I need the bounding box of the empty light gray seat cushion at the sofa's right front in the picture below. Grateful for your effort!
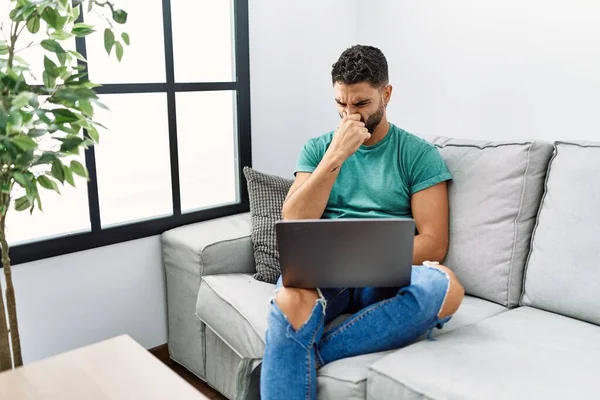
[367,307,600,399]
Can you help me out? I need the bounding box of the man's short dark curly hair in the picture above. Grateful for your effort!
[331,44,389,87]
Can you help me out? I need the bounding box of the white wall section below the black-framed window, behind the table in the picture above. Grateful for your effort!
[2,236,167,363]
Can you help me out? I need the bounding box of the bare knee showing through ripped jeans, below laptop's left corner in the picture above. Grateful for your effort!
[275,287,319,330]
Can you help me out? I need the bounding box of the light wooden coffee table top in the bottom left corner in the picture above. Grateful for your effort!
[0,335,207,400]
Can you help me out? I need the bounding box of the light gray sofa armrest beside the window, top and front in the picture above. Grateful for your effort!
[161,213,256,380]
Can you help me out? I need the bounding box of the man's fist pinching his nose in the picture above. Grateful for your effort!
[327,114,371,162]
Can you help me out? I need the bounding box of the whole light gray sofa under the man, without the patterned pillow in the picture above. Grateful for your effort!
[162,137,600,399]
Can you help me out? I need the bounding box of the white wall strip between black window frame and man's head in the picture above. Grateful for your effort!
[249,0,357,178]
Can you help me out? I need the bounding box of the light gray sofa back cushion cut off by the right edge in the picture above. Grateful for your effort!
[522,142,600,325]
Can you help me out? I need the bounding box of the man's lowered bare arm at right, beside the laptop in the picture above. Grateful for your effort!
[410,182,448,265]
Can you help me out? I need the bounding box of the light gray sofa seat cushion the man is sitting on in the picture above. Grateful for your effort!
[196,274,506,399]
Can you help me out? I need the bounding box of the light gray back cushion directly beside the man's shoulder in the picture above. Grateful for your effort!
[427,137,553,307]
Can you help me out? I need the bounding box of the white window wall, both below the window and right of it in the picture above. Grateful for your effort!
[9,0,356,362]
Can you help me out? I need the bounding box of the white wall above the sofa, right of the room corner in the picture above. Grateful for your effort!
[358,0,600,140]
